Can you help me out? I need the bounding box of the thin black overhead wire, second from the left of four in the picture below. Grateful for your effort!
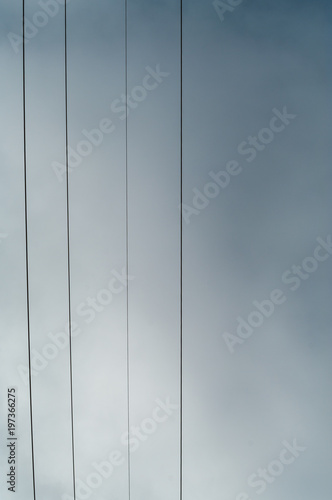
[64,0,76,500]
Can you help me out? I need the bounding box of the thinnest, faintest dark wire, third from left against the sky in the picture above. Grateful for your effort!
[124,0,131,500]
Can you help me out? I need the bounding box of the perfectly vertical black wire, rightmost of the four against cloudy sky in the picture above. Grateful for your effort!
[180,0,183,500]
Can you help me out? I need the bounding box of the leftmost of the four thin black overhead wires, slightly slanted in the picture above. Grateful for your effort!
[22,0,36,500]
